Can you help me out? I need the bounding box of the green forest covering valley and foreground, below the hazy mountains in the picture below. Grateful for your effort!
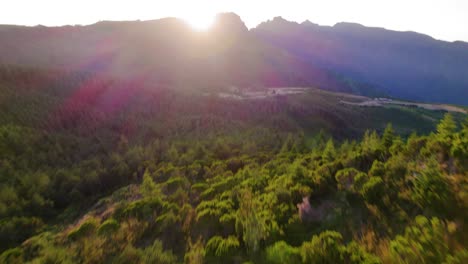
[0,67,468,264]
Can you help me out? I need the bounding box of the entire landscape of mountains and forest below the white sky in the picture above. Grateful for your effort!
[0,13,468,264]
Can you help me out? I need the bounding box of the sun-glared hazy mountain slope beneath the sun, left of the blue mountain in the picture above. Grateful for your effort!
[0,13,370,92]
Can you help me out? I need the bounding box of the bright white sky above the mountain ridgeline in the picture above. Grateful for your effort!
[0,0,468,41]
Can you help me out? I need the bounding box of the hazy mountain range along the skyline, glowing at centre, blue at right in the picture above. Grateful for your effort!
[0,13,468,105]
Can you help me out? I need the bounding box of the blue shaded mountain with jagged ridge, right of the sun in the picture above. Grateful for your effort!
[252,17,468,105]
